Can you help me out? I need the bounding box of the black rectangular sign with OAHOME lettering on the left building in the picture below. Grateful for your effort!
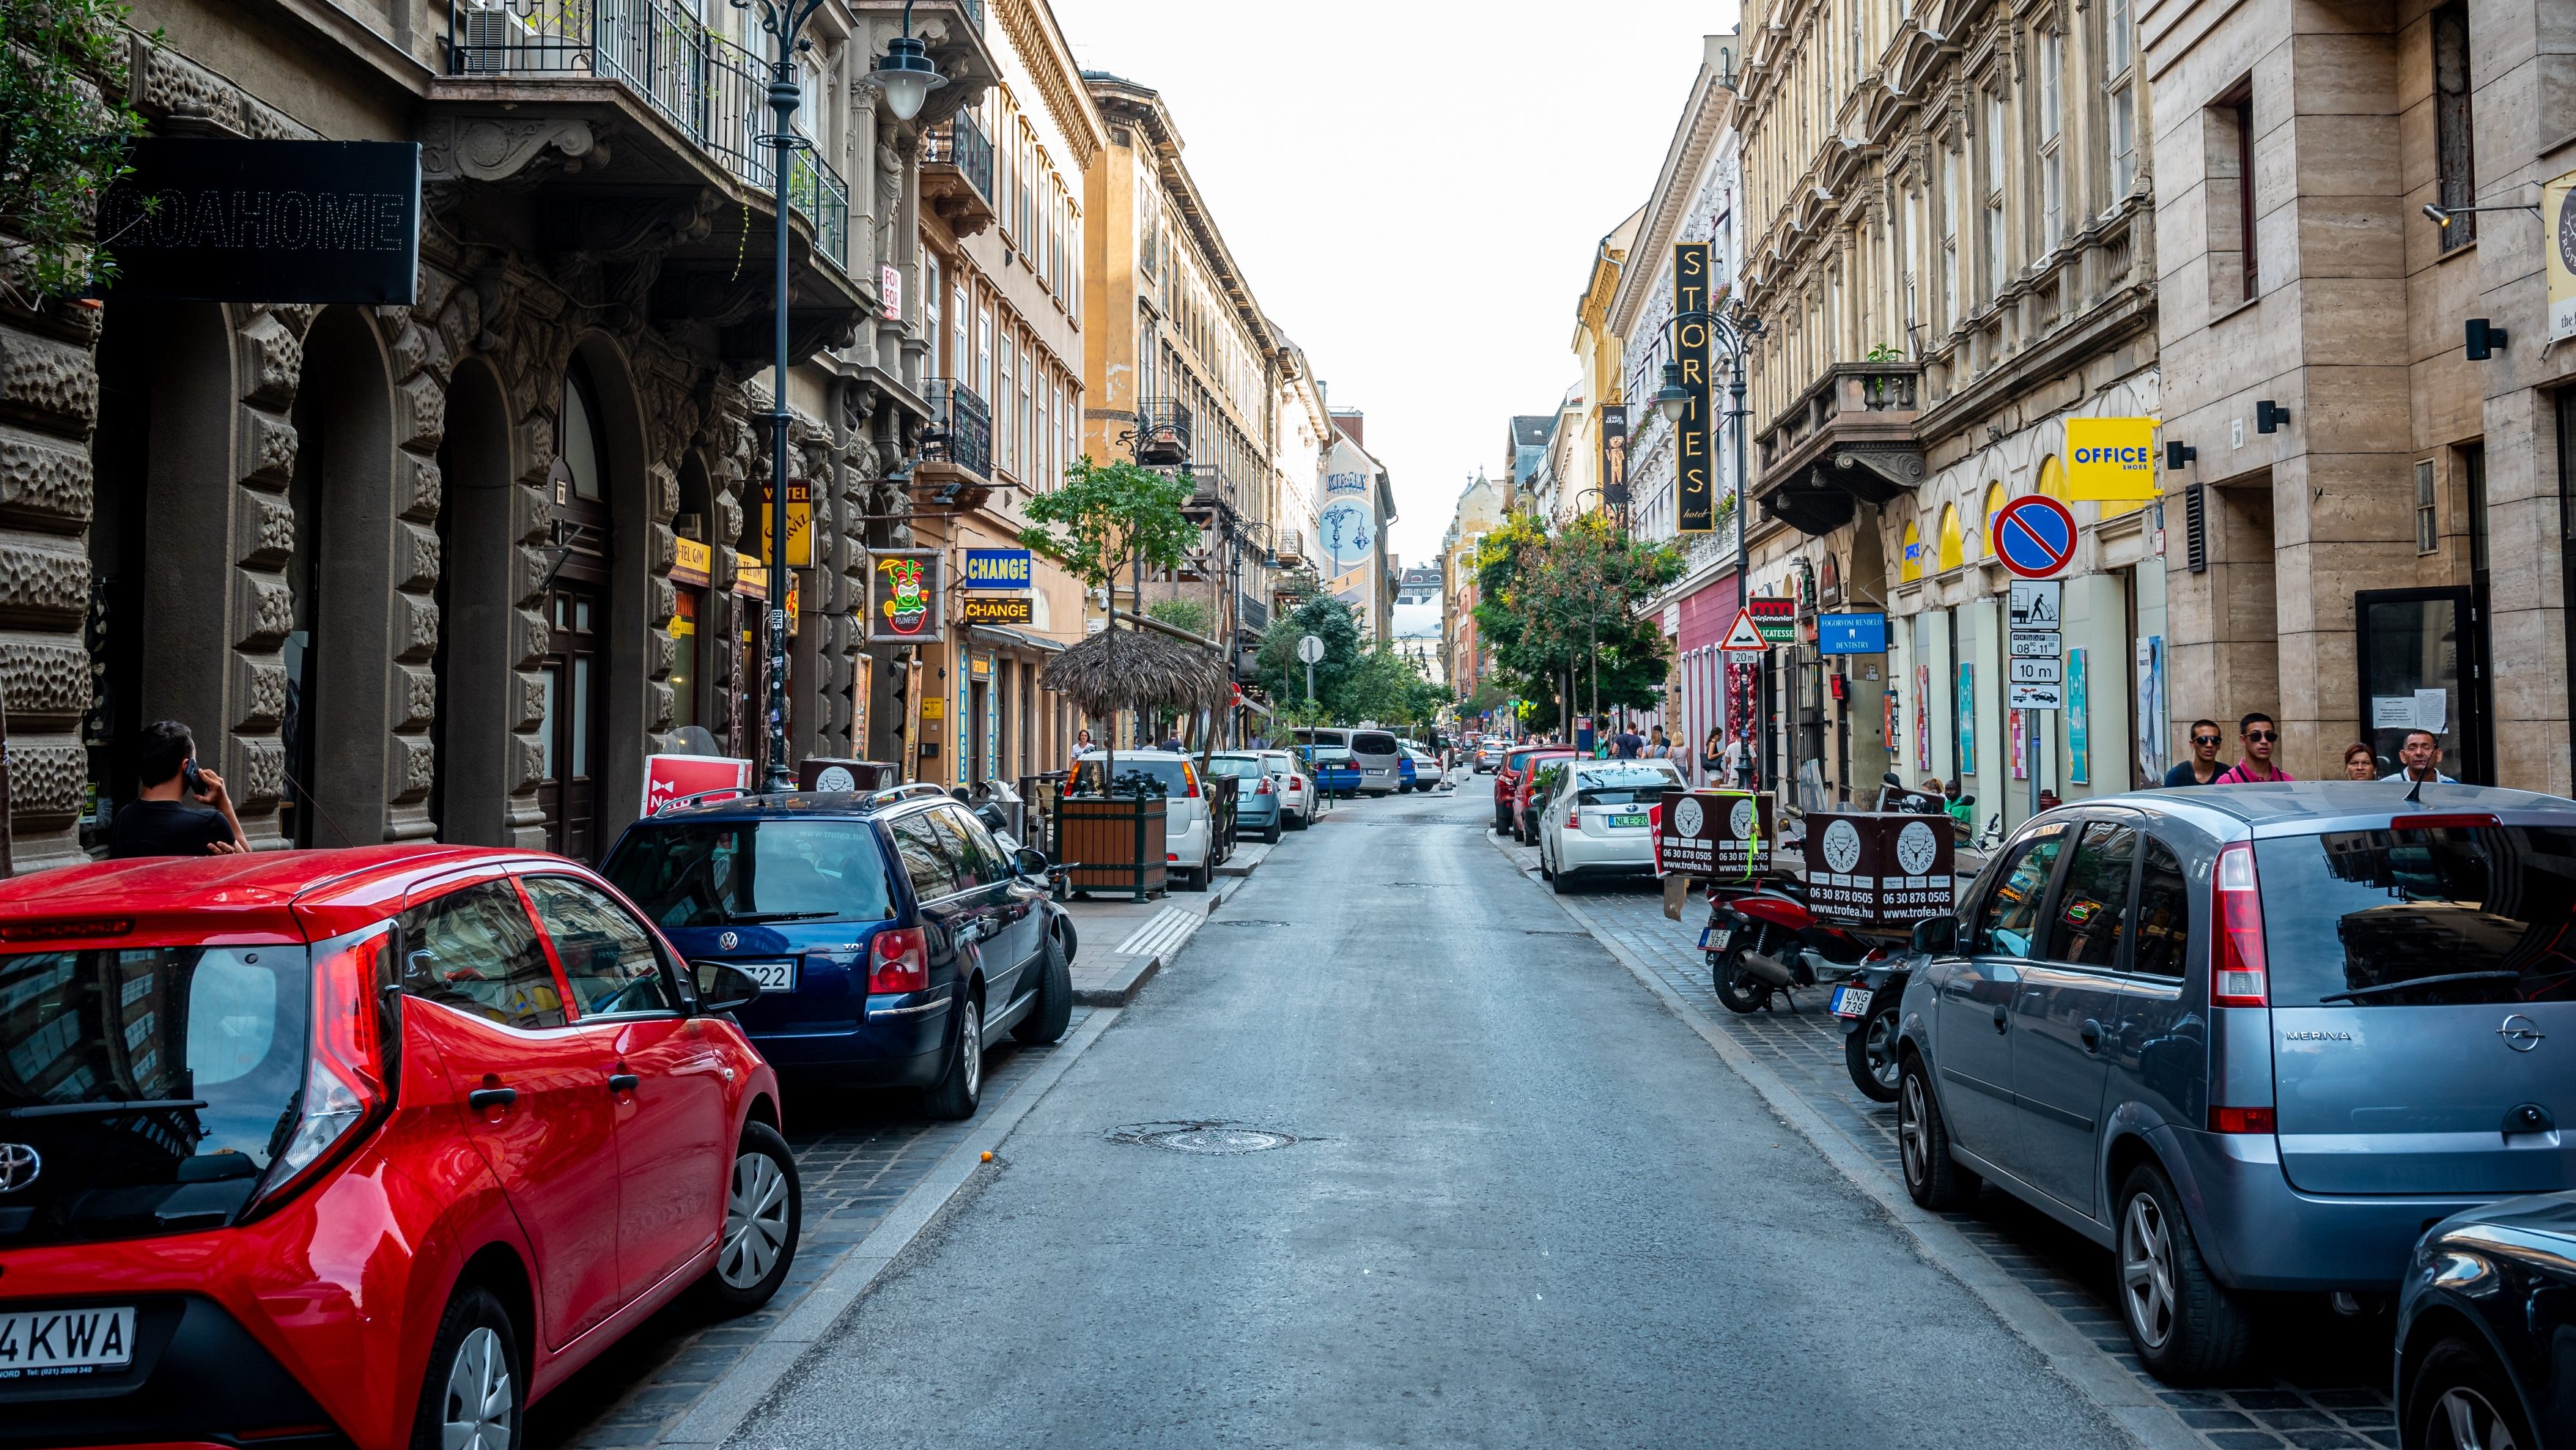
[98,136,420,306]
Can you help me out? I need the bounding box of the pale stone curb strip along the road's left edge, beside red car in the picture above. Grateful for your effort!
[652,1010,1118,1450]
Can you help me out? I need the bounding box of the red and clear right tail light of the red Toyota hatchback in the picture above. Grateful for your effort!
[255,922,399,1203]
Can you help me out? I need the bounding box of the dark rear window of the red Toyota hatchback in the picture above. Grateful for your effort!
[0,945,311,1244]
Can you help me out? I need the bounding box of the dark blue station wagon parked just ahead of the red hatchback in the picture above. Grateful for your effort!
[603,785,1074,1118]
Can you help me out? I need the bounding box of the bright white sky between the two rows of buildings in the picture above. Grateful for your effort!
[1051,0,1736,561]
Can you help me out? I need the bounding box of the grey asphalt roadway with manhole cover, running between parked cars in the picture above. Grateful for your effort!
[734,778,2127,1450]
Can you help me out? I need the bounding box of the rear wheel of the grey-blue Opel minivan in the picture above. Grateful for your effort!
[2115,1164,2254,1386]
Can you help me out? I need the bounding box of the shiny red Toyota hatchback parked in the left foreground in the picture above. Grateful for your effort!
[0,847,801,1450]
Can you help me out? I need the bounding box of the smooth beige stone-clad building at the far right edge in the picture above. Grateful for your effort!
[2138,0,2576,794]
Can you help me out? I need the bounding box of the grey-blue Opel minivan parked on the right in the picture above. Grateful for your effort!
[1896,780,2576,1383]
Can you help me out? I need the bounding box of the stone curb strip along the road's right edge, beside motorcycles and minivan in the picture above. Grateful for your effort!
[1491,837,2207,1450]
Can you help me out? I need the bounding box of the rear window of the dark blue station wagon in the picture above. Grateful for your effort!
[605,819,894,927]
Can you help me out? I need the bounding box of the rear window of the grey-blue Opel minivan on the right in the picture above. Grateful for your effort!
[2254,826,2576,1007]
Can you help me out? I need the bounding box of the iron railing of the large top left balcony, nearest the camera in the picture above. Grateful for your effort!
[449,0,844,270]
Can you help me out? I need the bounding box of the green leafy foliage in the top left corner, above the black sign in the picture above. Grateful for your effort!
[0,0,160,306]
